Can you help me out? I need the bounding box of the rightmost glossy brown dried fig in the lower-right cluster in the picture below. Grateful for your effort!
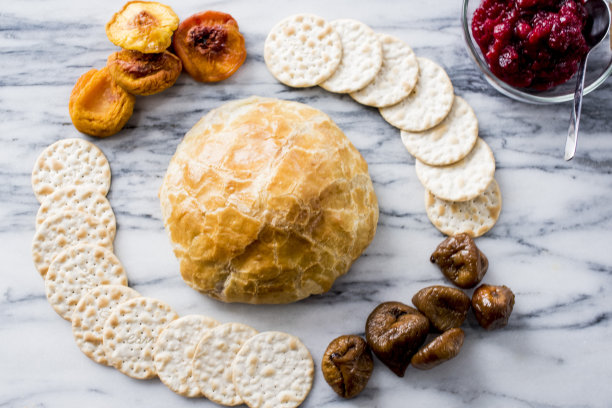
[472,285,514,330]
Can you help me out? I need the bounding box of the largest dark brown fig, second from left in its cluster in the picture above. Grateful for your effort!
[366,302,429,377]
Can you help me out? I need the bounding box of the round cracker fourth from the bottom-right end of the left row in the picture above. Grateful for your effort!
[102,297,178,380]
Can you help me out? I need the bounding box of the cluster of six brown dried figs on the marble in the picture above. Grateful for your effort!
[321,234,514,398]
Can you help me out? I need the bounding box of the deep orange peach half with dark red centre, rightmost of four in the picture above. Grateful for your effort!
[172,11,246,82]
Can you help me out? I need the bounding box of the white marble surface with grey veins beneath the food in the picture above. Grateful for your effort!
[0,0,612,408]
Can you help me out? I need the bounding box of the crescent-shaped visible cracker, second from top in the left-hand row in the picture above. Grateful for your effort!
[36,186,117,239]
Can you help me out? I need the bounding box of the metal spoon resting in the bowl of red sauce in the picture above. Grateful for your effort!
[565,0,610,160]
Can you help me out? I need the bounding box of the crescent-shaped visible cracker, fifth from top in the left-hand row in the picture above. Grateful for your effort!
[71,285,141,364]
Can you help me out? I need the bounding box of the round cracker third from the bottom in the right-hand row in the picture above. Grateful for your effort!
[401,96,478,166]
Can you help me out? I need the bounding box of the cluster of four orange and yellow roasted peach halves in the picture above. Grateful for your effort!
[68,1,246,137]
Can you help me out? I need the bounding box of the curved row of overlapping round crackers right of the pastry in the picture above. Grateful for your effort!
[264,14,501,237]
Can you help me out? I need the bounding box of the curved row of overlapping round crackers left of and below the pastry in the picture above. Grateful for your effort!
[32,139,314,408]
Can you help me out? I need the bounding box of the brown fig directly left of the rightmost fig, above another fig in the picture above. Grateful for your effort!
[412,286,470,331]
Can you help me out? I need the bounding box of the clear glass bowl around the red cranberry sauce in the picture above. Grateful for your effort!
[461,0,612,104]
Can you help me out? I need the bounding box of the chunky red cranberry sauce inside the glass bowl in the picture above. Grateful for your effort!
[472,0,589,91]
